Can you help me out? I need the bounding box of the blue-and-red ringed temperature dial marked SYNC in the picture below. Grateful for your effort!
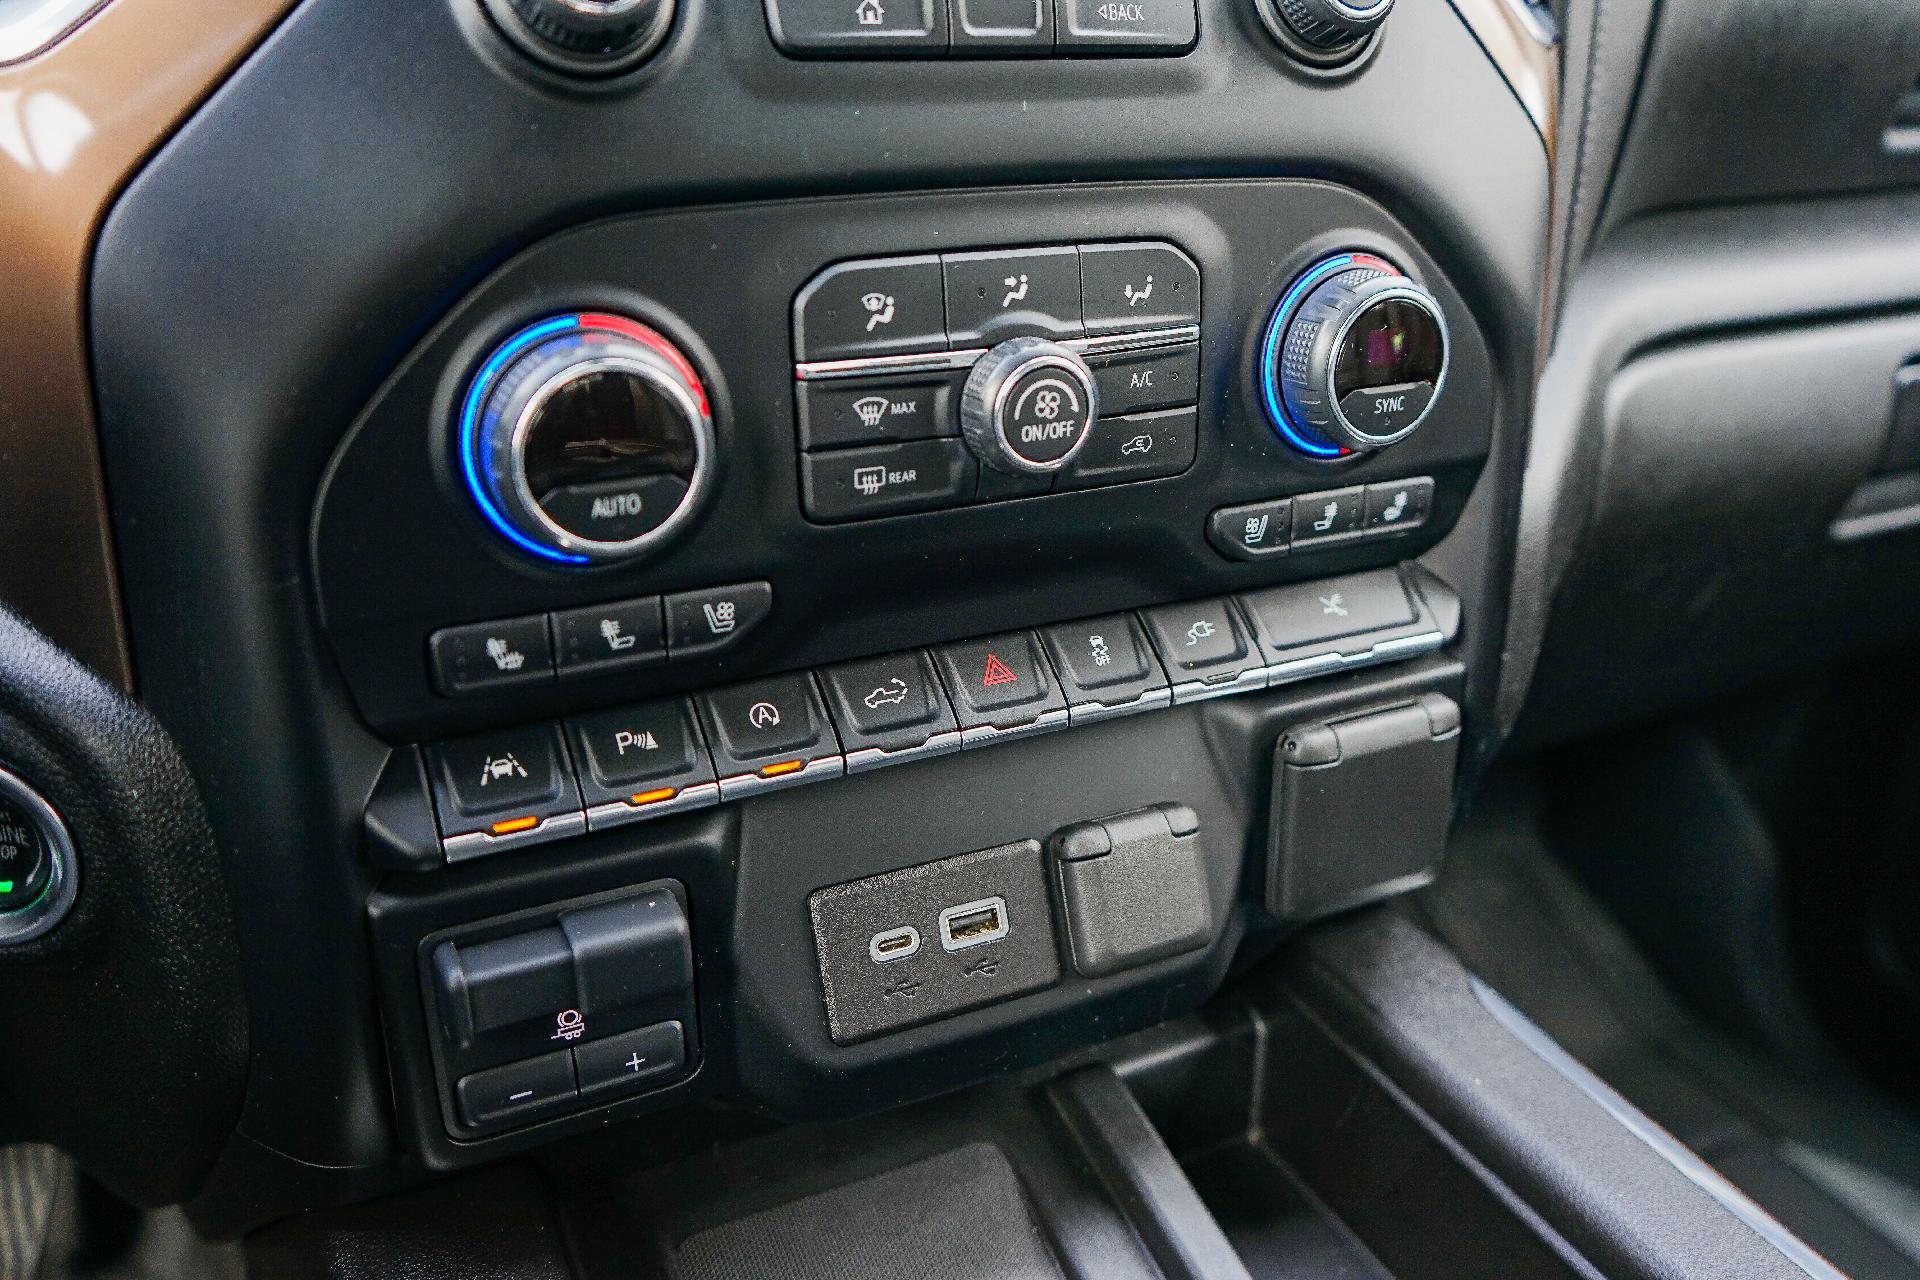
[1260,253,1448,459]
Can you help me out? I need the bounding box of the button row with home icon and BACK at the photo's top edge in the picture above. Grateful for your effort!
[766,0,1198,58]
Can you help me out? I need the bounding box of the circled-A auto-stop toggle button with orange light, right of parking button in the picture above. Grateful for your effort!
[699,672,845,798]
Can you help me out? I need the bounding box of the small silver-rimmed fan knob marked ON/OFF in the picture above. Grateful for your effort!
[960,338,1098,476]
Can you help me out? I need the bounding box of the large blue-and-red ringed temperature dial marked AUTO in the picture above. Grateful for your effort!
[455,315,714,566]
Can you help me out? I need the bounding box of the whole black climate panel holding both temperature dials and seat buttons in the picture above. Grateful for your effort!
[313,180,1498,740]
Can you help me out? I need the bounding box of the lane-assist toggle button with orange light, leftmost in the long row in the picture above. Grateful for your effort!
[426,723,586,860]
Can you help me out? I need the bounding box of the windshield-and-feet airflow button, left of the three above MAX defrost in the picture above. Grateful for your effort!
[793,253,947,361]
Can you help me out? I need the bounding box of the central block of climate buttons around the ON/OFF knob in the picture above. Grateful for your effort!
[793,242,1200,524]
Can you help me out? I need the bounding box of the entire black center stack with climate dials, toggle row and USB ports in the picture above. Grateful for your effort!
[74,0,1546,1230]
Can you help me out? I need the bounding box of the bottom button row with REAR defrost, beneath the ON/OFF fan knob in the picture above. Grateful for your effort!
[801,407,1200,524]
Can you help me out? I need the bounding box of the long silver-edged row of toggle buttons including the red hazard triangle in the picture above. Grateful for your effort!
[426,570,1450,862]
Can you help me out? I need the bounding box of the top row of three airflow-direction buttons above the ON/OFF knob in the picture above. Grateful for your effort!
[793,240,1200,362]
